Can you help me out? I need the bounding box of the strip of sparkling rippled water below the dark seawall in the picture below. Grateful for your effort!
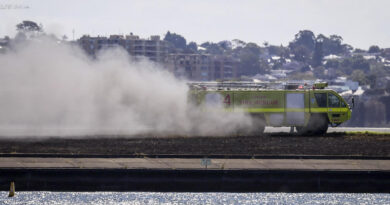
[0,192,390,205]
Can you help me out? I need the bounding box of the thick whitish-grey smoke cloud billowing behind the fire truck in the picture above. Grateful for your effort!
[0,38,249,136]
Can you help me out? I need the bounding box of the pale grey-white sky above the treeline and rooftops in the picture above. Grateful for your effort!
[0,0,390,49]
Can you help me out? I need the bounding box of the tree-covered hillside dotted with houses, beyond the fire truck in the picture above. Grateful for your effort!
[164,30,390,89]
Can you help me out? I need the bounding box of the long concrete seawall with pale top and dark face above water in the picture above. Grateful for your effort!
[0,157,390,193]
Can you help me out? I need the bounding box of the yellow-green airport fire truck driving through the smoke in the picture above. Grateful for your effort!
[189,82,351,134]
